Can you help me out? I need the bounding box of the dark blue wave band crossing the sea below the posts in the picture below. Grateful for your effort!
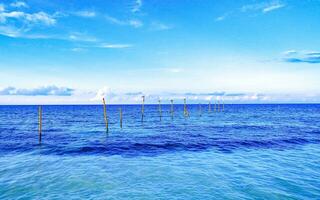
[0,135,320,156]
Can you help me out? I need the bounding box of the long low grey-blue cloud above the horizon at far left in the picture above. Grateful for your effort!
[0,86,74,96]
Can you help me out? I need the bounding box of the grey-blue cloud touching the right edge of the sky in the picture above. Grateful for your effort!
[283,50,320,64]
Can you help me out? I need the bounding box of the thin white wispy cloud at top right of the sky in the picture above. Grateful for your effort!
[241,1,286,13]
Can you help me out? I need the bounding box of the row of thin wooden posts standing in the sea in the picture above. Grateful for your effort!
[38,96,224,143]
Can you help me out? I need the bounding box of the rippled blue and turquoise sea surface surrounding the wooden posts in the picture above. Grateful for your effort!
[0,104,320,200]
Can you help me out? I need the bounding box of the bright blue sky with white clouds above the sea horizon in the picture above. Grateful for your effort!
[0,0,320,104]
